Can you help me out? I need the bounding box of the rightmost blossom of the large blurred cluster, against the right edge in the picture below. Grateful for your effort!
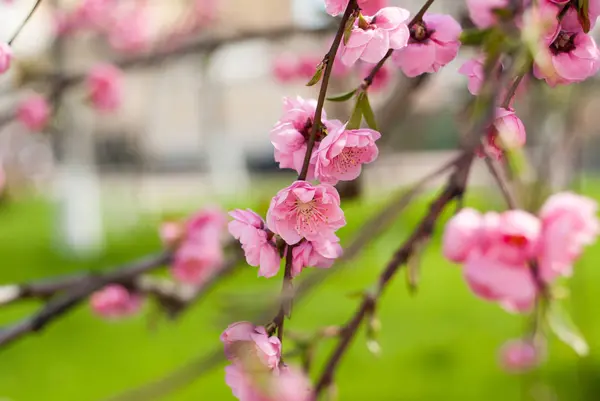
[539,192,600,281]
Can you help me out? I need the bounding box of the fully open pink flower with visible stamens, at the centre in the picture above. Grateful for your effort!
[267,181,346,245]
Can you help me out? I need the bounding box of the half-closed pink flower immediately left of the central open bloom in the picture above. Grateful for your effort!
[229,209,281,277]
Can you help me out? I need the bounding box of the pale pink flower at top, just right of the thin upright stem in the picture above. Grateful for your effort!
[341,7,410,66]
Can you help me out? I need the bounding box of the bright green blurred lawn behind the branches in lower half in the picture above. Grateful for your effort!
[0,188,600,401]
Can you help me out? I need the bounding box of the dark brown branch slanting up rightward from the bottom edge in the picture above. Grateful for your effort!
[314,151,473,398]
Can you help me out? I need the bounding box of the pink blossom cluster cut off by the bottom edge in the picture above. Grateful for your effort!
[221,322,312,401]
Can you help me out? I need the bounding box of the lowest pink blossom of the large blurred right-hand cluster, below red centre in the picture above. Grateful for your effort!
[464,248,537,312]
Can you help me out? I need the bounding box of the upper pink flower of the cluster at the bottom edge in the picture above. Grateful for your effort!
[220,322,281,370]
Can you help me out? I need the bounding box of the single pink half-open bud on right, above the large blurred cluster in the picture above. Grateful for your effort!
[484,107,527,160]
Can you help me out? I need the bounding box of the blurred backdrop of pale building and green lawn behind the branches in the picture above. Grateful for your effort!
[0,0,600,401]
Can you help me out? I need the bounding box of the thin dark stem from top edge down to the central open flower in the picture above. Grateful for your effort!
[298,0,358,181]
